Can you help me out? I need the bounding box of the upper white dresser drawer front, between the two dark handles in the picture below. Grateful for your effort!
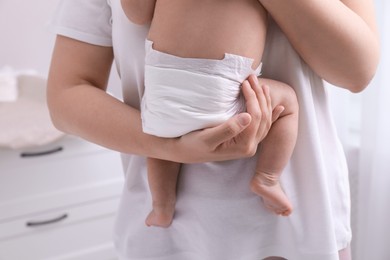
[0,152,124,223]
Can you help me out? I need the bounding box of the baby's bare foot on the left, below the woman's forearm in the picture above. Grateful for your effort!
[145,203,175,228]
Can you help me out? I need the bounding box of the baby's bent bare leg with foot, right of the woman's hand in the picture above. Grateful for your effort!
[251,79,298,216]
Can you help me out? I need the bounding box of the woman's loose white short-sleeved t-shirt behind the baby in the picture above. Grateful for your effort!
[51,0,351,260]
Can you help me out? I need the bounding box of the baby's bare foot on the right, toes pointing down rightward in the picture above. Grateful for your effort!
[251,173,293,216]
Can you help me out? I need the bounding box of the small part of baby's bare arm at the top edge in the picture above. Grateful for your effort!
[121,0,156,25]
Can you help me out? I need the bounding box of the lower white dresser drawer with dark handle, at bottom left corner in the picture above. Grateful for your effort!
[0,200,117,260]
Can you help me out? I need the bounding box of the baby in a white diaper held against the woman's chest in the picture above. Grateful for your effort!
[121,0,298,227]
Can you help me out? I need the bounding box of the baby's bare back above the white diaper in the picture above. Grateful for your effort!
[149,0,267,67]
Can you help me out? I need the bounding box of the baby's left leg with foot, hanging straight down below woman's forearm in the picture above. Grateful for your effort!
[145,158,180,227]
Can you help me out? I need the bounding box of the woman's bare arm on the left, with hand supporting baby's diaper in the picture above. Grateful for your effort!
[47,36,281,163]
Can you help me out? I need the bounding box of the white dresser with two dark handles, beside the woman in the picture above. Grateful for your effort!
[0,136,123,260]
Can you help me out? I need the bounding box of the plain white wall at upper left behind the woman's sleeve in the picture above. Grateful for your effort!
[0,0,121,98]
